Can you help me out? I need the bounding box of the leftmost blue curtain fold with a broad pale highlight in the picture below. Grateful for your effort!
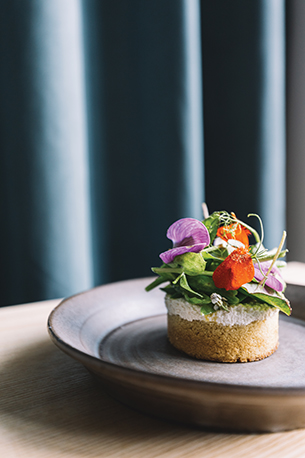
[0,0,93,305]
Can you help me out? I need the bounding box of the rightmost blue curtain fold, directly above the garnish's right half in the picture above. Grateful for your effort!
[201,0,286,248]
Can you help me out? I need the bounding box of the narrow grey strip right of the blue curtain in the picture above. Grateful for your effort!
[287,0,305,262]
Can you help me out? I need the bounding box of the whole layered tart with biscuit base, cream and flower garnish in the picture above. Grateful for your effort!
[146,211,291,362]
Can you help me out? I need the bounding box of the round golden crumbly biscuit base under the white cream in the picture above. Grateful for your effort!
[167,313,278,363]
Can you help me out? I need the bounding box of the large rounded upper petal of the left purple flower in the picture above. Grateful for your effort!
[166,218,210,247]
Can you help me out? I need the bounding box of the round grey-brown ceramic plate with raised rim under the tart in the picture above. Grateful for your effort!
[48,278,305,432]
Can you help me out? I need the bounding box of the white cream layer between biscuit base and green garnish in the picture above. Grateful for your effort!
[165,296,279,326]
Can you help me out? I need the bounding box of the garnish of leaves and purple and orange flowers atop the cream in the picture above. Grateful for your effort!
[146,211,291,315]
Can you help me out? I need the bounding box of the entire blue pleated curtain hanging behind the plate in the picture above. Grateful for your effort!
[0,0,285,305]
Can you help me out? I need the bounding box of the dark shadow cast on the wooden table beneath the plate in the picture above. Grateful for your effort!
[0,338,221,457]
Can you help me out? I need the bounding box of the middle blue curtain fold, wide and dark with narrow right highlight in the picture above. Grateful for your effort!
[83,0,204,283]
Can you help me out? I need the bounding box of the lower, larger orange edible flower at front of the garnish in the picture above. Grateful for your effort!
[213,248,254,291]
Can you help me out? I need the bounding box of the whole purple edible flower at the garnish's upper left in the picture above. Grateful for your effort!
[160,218,210,264]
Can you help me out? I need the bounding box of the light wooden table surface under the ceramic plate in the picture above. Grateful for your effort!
[0,272,305,458]
